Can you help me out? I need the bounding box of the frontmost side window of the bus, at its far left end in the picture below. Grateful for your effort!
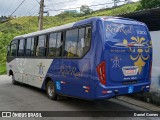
[10,40,18,57]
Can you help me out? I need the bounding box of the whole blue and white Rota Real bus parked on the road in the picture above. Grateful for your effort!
[7,17,152,100]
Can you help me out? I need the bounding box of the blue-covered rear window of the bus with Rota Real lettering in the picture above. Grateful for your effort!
[105,22,150,47]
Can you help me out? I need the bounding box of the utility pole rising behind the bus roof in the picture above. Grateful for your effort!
[38,0,44,30]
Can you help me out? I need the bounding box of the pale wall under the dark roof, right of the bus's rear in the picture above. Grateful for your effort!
[131,31,160,105]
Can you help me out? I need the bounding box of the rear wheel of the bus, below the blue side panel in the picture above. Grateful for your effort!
[46,80,57,100]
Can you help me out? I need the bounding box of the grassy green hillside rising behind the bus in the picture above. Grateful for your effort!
[0,2,140,74]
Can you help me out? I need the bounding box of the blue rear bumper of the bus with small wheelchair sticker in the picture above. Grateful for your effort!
[96,82,150,99]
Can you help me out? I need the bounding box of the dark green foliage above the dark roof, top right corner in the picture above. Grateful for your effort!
[141,0,160,9]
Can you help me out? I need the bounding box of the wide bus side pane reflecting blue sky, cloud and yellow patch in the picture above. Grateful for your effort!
[63,29,78,58]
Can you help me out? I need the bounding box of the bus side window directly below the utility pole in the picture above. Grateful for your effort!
[36,35,46,57]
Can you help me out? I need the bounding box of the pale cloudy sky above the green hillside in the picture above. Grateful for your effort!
[0,0,139,16]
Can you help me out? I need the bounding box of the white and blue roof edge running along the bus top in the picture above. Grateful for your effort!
[14,16,143,39]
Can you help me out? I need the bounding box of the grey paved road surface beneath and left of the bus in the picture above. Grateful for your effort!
[0,76,158,120]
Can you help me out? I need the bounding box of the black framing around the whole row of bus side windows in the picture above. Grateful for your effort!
[10,23,93,59]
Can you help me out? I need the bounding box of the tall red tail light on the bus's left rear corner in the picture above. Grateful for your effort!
[97,61,106,85]
